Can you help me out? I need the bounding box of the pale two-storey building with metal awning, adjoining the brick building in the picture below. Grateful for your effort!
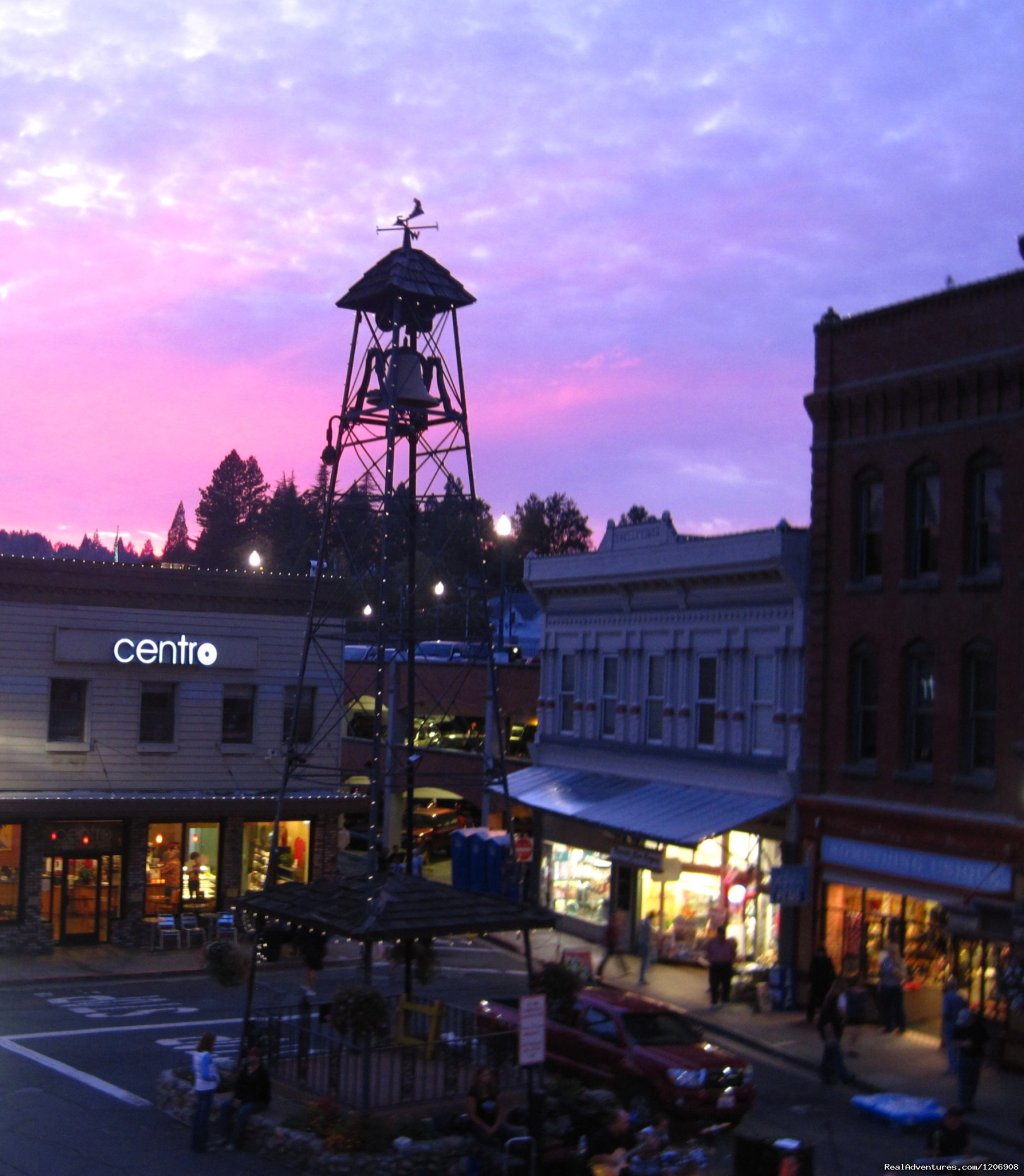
[509,515,808,958]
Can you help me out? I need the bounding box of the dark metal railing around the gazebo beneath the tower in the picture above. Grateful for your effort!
[247,1003,524,1111]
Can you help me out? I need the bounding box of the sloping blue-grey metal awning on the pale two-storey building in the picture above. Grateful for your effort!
[490,764,792,846]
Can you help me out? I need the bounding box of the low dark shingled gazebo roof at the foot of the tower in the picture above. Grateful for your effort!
[239,861,555,943]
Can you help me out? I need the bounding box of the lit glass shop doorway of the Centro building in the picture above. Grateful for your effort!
[41,854,121,946]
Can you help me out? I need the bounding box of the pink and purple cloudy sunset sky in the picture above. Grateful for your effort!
[0,0,1024,553]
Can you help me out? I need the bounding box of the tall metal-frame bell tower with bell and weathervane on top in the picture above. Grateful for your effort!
[273,200,508,873]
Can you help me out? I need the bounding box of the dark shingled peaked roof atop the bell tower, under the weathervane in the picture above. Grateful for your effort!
[335,245,476,329]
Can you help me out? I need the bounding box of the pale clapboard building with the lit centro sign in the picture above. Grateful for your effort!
[0,557,366,950]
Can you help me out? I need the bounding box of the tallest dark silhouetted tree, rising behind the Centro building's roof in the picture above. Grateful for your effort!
[195,449,268,568]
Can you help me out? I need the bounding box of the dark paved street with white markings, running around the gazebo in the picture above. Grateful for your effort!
[0,938,1020,1176]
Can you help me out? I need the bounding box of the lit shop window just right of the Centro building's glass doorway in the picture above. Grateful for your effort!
[146,821,220,916]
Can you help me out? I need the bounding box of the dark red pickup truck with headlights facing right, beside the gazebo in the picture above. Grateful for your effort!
[477,985,755,1123]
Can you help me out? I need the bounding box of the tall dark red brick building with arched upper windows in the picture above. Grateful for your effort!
[799,270,1024,1039]
